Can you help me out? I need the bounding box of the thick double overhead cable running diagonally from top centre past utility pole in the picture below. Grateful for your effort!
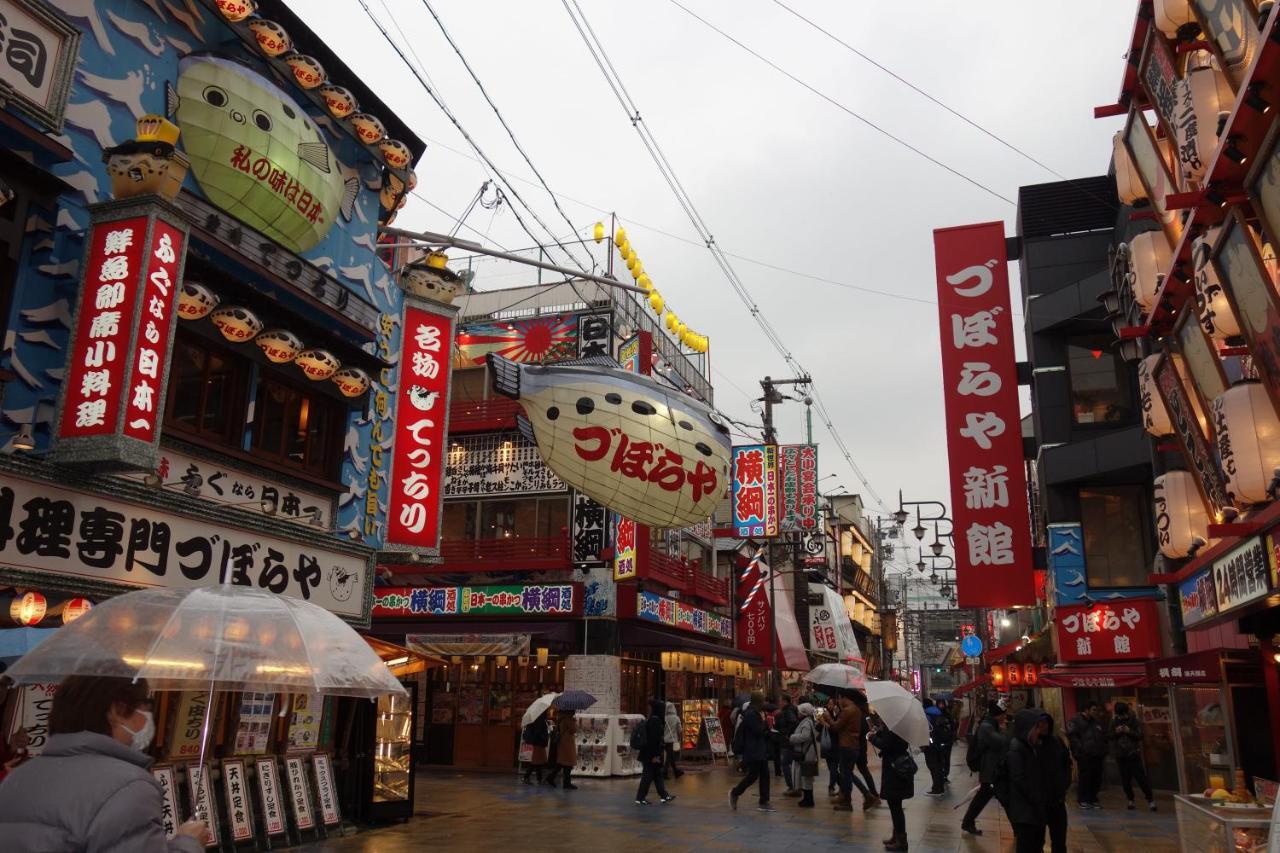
[561,0,888,512]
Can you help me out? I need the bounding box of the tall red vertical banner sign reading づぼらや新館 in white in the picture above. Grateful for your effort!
[933,222,1036,607]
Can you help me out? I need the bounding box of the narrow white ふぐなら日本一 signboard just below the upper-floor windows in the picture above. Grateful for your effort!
[122,447,333,530]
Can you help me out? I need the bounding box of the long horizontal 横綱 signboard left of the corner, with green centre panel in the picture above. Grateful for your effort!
[374,583,582,617]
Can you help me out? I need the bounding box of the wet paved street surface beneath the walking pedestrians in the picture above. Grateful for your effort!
[303,749,1178,853]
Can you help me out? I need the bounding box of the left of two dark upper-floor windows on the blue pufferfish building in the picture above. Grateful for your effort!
[165,334,250,448]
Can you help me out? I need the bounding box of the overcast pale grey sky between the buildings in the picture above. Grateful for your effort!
[289,0,1137,563]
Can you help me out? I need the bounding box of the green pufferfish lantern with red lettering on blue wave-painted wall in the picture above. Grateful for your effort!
[165,54,360,252]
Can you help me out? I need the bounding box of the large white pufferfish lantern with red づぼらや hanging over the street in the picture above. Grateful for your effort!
[488,353,731,528]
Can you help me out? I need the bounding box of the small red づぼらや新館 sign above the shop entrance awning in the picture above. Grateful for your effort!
[1053,598,1160,662]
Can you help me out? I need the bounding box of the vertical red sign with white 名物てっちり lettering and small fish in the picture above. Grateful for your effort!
[385,296,457,556]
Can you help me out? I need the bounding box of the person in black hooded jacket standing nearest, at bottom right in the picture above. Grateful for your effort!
[996,708,1071,853]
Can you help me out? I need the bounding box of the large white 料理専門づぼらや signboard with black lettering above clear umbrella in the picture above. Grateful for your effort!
[0,476,372,620]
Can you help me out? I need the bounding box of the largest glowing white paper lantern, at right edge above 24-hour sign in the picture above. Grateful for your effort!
[1213,382,1280,503]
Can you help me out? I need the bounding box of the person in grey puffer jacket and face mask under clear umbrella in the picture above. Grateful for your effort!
[0,675,205,853]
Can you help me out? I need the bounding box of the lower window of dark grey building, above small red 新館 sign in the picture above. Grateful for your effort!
[1080,485,1152,587]
